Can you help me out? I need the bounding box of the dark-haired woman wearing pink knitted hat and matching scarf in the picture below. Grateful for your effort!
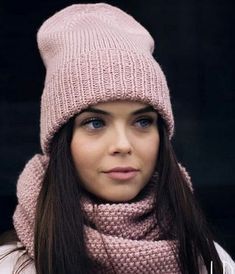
[0,4,234,274]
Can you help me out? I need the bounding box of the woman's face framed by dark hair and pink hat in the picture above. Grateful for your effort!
[71,101,160,202]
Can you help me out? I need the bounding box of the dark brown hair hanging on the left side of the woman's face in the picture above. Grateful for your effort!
[34,115,91,274]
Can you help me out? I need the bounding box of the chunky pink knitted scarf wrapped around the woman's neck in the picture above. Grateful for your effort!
[14,155,185,274]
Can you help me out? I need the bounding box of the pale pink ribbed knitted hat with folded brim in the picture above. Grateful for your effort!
[37,3,174,154]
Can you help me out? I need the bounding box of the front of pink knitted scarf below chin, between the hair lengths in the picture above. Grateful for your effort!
[83,177,180,274]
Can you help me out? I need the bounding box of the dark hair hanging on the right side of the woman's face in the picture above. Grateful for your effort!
[156,117,223,274]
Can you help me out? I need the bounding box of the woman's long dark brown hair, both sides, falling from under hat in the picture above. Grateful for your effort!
[0,116,222,274]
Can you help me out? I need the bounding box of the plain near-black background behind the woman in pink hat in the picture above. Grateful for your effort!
[0,0,235,257]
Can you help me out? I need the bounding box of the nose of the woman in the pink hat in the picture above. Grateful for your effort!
[109,128,132,155]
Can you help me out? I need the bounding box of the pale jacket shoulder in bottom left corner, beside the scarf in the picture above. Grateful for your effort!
[0,242,36,274]
